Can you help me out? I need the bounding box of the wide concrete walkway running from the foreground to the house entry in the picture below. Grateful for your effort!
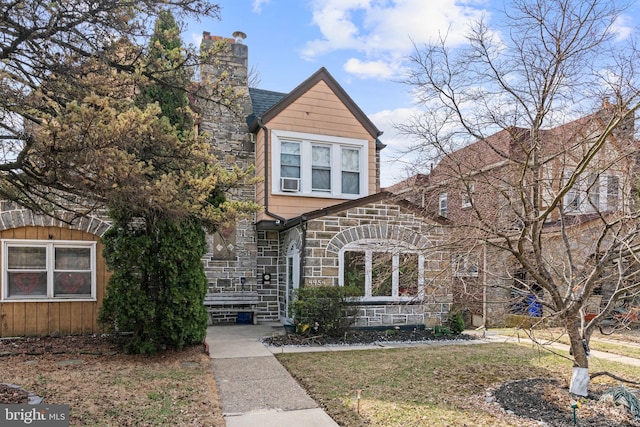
[206,323,338,427]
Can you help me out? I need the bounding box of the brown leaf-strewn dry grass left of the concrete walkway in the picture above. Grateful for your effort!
[0,346,225,427]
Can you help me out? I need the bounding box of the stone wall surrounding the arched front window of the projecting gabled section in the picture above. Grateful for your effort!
[303,203,453,326]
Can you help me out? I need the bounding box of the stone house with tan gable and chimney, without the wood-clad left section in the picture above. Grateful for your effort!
[200,33,451,326]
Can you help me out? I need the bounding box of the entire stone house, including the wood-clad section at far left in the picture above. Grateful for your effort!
[0,33,452,337]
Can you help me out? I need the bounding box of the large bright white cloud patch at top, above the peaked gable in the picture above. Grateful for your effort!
[302,0,484,78]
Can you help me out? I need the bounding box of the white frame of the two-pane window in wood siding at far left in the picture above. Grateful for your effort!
[0,239,97,302]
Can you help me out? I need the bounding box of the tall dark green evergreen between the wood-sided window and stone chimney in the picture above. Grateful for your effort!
[101,11,213,353]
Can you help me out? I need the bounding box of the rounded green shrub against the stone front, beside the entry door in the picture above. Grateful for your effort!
[291,286,357,336]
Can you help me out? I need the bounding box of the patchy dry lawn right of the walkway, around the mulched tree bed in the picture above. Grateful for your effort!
[278,344,640,427]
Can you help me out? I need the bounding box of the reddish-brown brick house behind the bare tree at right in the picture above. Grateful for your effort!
[389,105,638,325]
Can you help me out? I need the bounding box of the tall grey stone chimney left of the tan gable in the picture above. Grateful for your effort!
[198,31,257,292]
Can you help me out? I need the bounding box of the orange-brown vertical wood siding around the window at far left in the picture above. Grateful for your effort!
[0,227,110,337]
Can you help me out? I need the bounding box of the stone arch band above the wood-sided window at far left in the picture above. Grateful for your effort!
[0,209,111,237]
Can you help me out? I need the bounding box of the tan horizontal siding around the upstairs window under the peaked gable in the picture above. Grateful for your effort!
[256,81,376,220]
